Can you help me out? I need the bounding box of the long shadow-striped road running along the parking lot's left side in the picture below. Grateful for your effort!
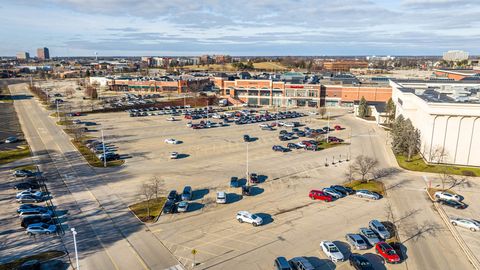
[10,84,180,269]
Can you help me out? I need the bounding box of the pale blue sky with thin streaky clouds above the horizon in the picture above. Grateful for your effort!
[0,0,480,56]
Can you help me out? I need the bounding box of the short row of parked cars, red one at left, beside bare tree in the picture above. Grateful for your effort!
[308,185,382,202]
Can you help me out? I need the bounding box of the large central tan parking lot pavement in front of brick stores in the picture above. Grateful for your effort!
[76,108,403,269]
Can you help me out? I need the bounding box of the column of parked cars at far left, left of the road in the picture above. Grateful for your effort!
[13,169,57,235]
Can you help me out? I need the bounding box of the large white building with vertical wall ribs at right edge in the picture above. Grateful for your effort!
[390,80,480,166]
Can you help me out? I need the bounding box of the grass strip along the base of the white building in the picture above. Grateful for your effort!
[396,155,480,176]
